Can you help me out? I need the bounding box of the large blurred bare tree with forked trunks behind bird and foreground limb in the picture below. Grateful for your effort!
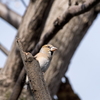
[0,0,100,100]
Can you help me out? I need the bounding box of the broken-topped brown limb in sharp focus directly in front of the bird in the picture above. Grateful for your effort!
[14,39,51,100]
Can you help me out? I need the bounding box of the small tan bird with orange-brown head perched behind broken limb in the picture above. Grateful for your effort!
[25,44,57,85]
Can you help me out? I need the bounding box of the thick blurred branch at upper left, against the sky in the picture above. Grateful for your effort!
[0,2,22,29]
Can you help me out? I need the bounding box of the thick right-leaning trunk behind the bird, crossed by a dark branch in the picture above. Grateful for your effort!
[43,0,98,96]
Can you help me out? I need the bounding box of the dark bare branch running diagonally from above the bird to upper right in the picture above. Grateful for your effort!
[32,0,100,55]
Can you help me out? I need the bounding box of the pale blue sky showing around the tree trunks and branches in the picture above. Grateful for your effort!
[0,0,100,100]
